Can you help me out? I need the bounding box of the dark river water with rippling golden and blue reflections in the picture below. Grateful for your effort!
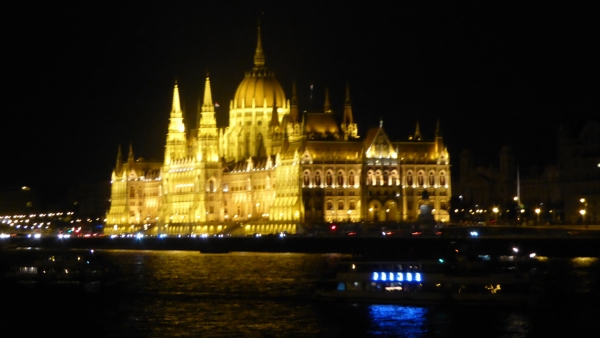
[7,250,600,337]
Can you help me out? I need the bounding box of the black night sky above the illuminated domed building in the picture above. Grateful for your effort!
[0,1,600,198]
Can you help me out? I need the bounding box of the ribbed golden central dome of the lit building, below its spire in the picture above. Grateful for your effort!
[234,67,285,108]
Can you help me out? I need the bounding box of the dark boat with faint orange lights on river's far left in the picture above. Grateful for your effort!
[0,247,116,292]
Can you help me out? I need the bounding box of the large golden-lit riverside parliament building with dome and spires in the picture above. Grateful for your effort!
[105,29,451,235]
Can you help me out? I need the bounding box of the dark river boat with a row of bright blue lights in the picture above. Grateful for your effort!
[317,259,537,306]
